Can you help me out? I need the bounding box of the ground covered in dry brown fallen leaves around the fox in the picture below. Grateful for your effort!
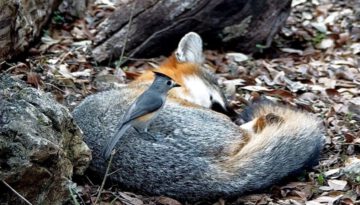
[5,0,360,205]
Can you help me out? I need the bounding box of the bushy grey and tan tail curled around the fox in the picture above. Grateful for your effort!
[215,103,325,192]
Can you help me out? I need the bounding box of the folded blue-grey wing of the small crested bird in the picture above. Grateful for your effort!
[123,92,164,124]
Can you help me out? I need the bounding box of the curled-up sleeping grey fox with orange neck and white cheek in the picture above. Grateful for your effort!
[73,32,324,201]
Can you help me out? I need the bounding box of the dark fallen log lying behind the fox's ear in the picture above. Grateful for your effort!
[93,0,291,62]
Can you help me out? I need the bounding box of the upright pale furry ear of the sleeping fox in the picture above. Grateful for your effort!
[175,32,204,64]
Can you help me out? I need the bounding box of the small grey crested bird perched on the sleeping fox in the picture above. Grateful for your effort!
[102,71,180,159]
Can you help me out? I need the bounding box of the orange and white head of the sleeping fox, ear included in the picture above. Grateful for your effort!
[137,32,233,114]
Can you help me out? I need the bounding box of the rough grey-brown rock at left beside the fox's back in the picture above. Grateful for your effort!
[0,75,91,204]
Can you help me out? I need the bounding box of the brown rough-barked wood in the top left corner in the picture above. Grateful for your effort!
[0,0,61,60]
